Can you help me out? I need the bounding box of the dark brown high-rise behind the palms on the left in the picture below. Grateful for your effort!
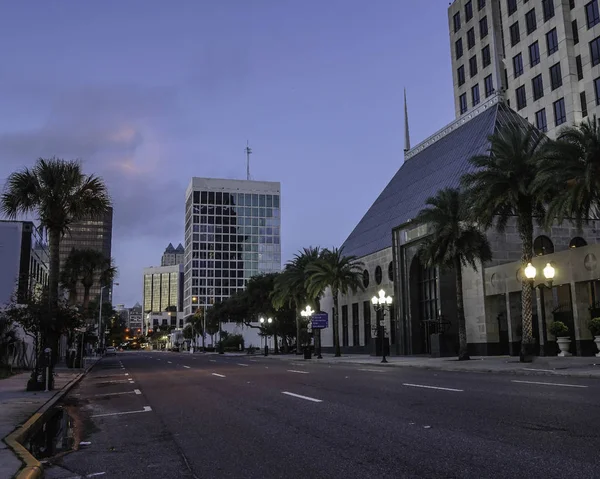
[60,208,113,303]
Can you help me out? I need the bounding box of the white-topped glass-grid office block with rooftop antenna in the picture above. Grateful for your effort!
[184,178,281,316]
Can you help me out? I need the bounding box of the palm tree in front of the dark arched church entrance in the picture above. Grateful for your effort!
[414,188,492,361]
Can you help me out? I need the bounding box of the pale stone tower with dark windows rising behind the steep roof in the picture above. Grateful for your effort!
[448,0,600,137]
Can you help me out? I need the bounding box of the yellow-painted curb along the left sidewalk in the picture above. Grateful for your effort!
[4,358,102,479]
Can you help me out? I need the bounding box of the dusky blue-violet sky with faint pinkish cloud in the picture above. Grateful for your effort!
[0,0,454,306]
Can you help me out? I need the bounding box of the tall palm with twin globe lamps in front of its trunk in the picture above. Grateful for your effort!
[462,125,547,361]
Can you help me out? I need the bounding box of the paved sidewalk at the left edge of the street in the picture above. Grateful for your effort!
[0,360,96,479]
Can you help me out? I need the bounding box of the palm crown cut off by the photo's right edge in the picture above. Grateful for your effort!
[535,116,600,228]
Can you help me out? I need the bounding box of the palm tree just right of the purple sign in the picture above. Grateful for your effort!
[307,248,364,357]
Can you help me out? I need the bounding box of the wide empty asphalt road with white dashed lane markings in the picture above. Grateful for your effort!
[46,352,600,479]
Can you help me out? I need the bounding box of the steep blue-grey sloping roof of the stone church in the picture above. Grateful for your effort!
[343,100,527,257]
